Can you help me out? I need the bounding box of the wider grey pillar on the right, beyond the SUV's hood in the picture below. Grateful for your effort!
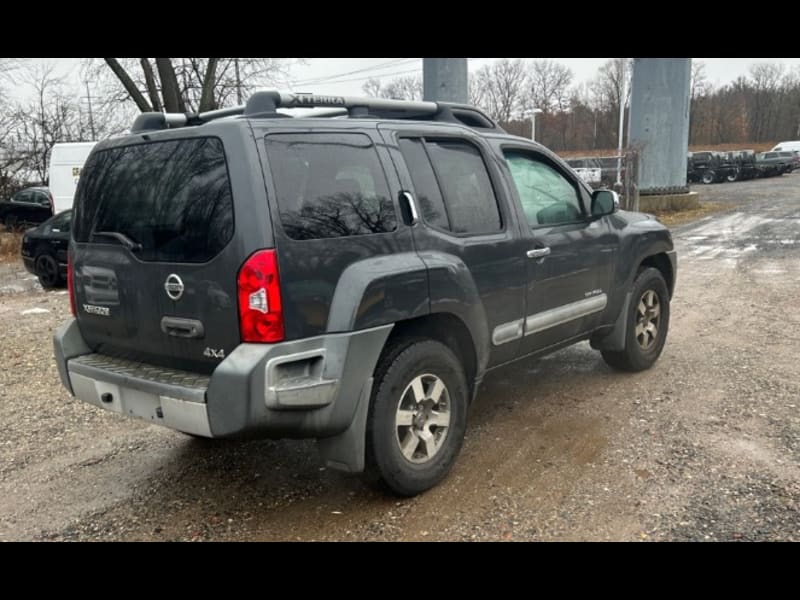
[628,58,692,194]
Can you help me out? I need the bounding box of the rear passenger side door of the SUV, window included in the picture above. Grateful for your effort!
[381,124,525,367]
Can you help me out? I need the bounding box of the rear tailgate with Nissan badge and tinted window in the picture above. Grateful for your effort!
[72,127,255,372]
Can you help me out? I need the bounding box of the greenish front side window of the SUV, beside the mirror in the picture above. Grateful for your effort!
[505,152,583,228]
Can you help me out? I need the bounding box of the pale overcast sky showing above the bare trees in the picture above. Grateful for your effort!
[12,58,800,97]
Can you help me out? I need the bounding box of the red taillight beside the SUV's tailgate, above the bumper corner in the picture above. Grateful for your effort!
[238,250,284,344]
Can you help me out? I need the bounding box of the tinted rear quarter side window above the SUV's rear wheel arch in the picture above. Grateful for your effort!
[266,133,397,240]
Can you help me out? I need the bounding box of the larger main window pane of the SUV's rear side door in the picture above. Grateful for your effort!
[425,139,503,234]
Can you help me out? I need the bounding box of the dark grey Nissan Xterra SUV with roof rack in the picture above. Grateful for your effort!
[55,92,676,495]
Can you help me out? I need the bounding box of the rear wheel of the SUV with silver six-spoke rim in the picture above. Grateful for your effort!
[366,339,468,497]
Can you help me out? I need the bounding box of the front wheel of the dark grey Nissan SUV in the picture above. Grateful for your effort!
[602,268,670,373]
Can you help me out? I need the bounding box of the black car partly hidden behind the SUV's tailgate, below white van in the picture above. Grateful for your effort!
[22,209,72,289]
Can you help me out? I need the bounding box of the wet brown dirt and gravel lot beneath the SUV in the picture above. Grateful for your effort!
[0,174,800,541]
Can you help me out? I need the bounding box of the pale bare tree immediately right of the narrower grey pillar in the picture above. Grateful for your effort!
[471,58,528,123]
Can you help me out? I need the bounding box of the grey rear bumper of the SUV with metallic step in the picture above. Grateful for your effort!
[54,319,392,438]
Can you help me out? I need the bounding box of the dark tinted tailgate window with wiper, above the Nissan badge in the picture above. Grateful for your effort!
[73,137,233,263]
